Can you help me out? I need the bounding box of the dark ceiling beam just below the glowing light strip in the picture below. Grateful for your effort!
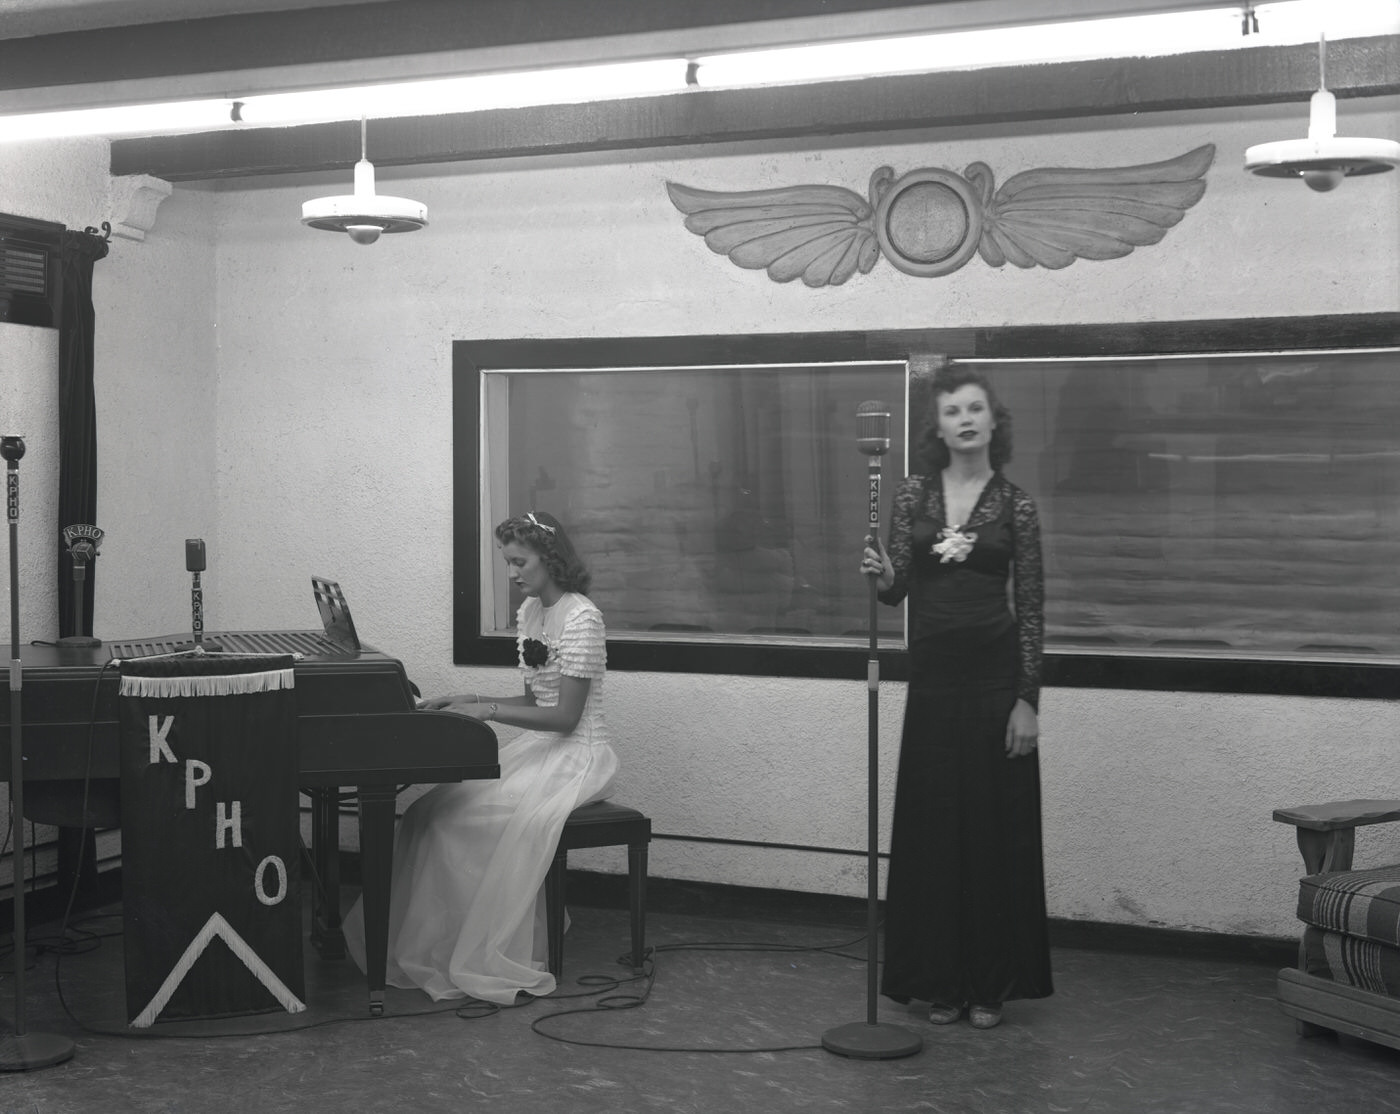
[112,35,1400,182]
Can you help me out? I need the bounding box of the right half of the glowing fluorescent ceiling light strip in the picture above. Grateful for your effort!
[696,0,1400,87]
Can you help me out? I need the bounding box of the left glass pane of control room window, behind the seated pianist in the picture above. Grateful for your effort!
[480,362,906,645]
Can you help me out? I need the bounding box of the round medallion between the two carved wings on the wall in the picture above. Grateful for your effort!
[875,168,981,276]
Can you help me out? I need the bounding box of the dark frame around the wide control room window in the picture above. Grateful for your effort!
[452,313,1400,700]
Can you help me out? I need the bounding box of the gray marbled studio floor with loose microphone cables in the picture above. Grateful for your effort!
[0,907,1400,1114]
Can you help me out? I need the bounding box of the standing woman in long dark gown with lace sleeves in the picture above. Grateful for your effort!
[861,368,1053,1029]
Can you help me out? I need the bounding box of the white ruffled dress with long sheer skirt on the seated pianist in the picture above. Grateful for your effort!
[344,592,617,1005]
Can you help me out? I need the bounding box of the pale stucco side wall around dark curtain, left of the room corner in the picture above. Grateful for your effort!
[0,140,217,879]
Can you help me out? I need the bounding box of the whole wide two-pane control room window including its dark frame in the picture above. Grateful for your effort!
[454,324,1400,688]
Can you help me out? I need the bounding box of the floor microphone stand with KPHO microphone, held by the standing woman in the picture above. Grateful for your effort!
[822,402,924,1059]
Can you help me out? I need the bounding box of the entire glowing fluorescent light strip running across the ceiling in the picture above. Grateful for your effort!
[0,0,1400,141]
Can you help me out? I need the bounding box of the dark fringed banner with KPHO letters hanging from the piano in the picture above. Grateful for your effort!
[120,652,305,1027]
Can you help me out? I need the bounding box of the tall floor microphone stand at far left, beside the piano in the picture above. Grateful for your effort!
[0,437,73,1072]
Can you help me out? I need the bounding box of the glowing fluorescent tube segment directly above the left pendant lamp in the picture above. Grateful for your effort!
[238,59,687,127]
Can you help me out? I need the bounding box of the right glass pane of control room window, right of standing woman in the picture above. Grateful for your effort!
[967,348,1400,661]
